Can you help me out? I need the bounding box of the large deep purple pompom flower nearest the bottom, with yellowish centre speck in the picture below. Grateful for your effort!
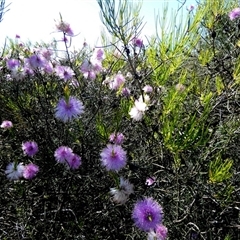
[132,198,163,232]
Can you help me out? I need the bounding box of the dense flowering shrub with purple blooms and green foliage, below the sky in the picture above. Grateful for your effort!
[0,0,240,240]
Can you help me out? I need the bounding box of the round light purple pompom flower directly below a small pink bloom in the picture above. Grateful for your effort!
[100,144,127,171]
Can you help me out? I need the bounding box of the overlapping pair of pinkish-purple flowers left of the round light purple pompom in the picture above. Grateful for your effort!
[54,146,82,169]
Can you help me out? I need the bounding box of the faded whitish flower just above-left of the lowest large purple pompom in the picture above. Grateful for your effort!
[110,177,134,204]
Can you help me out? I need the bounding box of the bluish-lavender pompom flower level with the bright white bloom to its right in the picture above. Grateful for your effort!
[55,96,84,122]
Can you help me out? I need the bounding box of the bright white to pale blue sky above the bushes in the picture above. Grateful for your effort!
[0,0,195,48]
